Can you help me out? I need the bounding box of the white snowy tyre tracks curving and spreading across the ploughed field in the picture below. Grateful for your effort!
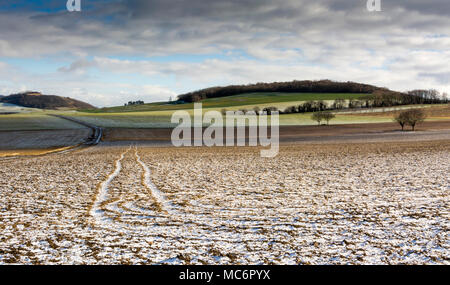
[90,145,250,244]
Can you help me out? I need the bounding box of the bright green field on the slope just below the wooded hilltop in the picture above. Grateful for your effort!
[84,92,367,113]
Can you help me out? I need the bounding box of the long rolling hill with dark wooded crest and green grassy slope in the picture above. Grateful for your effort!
[83,80,405,113]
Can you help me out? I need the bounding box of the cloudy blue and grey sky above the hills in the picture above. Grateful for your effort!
[0,0,450,107]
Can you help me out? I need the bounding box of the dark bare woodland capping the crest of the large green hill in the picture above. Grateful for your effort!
[178,80,398,103]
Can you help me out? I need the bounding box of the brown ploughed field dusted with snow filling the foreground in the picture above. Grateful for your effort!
[0,140,450,264]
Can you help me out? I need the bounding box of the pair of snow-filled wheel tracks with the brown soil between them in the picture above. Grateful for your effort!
[85,146,255,242]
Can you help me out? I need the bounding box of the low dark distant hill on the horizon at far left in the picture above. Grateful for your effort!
[0,91,95,109]
